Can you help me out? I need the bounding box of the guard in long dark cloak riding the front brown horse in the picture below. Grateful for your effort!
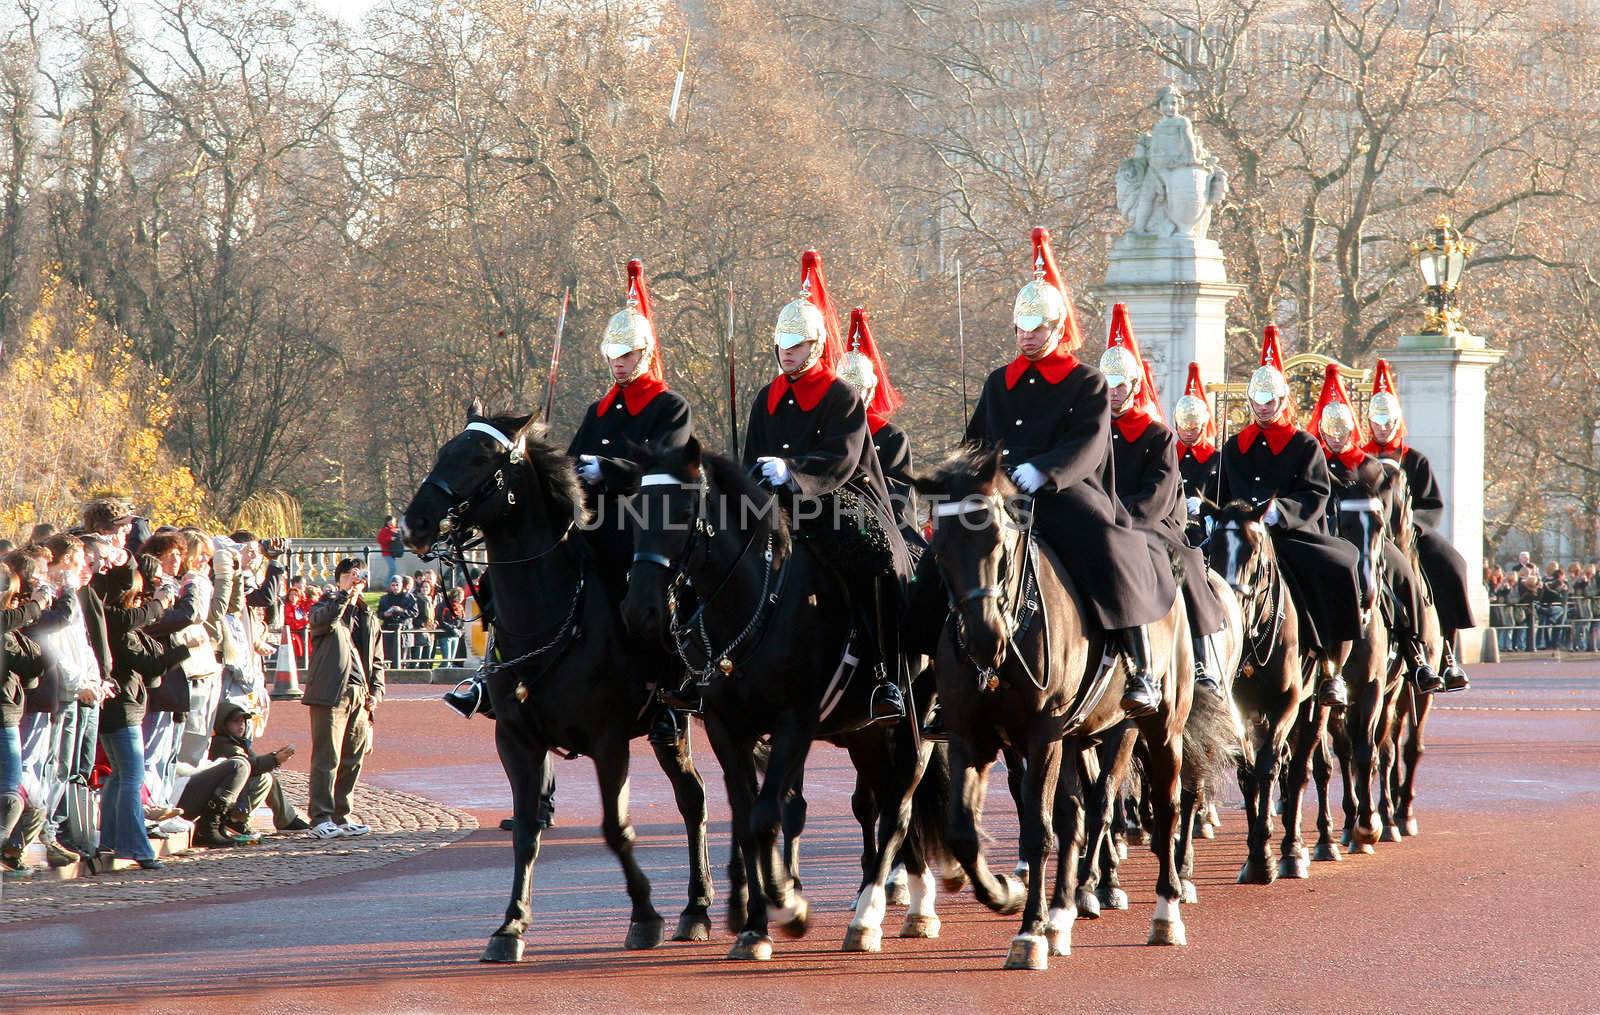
[966,227,1176,717]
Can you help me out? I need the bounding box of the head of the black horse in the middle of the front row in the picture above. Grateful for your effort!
[622,437,706,640]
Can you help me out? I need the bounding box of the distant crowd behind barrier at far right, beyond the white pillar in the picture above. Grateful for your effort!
[1483,551,1600,652]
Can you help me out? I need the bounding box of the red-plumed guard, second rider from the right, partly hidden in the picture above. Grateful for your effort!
[1310,363,1443,695]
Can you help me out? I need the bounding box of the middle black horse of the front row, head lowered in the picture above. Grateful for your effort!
[622,439,938,959]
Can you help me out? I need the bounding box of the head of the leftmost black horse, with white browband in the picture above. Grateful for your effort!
[400,399,582,552]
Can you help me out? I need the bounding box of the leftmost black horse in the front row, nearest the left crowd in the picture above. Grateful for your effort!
[402,402,712,962]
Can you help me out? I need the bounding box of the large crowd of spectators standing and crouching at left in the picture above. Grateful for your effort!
[0,499,384,877]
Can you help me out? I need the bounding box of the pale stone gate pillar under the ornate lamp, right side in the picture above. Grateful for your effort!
[1384,335,1506,663]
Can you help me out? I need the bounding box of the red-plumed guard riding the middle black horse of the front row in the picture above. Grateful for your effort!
[744,250,912,724]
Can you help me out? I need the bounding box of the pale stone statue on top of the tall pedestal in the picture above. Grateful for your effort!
[1117,85,1227,240]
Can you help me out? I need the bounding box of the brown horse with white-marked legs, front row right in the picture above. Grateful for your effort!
[915,450,1192,969]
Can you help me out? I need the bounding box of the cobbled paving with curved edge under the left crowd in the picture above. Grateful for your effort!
[0,772,478,924]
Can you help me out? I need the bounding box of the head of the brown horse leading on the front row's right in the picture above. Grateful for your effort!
[914,448,1018,669]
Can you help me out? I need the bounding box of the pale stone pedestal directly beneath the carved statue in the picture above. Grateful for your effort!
[1093,234,1243,403]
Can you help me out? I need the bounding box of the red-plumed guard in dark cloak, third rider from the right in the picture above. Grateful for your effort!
[1218,325,1362,704]
